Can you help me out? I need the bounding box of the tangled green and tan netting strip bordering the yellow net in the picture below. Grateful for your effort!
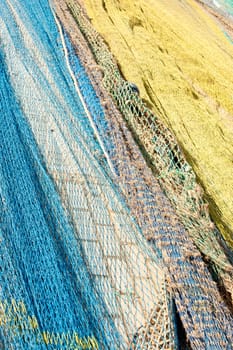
[67,1,233,300]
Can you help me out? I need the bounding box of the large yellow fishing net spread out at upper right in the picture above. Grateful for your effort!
[70,0,233,248]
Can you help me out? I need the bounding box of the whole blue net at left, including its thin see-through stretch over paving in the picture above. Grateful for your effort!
[0,0,177,349]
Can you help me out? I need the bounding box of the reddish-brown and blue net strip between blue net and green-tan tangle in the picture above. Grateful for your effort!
[52,2,232,349]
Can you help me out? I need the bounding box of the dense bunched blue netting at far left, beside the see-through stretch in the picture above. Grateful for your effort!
[0,45,120,349]
